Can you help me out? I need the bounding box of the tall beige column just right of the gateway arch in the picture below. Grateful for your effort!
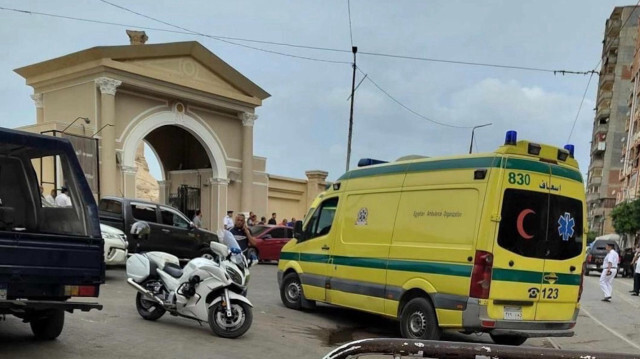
[240,112,258,212]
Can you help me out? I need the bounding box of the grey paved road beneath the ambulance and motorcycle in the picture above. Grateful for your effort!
[0,264,640,359]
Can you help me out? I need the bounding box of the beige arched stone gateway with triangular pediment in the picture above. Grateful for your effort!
[15,38,280,229]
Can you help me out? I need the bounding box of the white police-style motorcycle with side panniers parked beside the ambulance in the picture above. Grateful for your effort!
[127,222,253,338]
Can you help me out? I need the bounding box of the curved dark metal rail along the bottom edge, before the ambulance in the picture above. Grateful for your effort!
[324,339,640,359]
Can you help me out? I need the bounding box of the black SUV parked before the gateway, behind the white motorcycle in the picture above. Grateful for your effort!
[99,197,218,259]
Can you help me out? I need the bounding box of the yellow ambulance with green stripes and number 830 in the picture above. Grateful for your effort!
[278,131,586,345]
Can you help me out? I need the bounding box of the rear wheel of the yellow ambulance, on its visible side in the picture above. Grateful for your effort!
[400,297,441,340]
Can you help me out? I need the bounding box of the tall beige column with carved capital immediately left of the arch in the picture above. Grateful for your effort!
[95,77,122,197]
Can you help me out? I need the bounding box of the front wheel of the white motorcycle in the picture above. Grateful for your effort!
[209,300,253,338]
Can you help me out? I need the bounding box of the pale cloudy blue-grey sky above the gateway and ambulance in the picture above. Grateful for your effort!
[0,0,634,179]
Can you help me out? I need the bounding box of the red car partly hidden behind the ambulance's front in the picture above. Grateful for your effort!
[247,225,293,262]
